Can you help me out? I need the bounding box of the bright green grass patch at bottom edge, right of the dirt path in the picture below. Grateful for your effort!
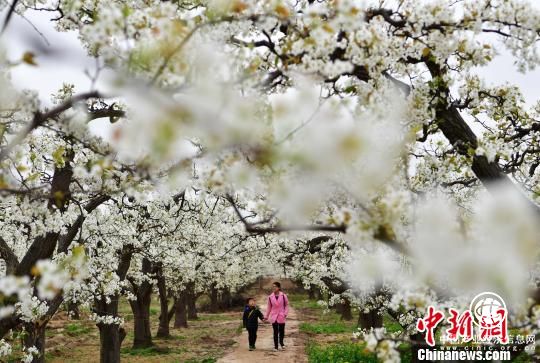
[306,343,378,363]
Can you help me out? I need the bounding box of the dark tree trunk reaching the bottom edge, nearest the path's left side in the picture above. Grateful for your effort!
[96,296,126,363]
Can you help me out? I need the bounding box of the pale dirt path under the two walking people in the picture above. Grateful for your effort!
[218,295,307,363]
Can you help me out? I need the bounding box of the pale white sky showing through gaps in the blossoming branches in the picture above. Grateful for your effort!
[0,6,540,138]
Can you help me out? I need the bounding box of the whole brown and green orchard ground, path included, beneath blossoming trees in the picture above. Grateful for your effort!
[9,278,528,363]
